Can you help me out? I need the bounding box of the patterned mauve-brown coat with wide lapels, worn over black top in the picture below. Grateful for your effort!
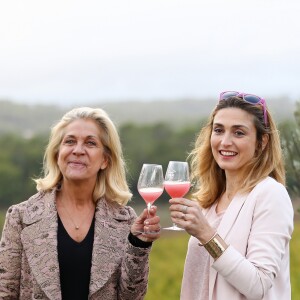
[0,190,150,300]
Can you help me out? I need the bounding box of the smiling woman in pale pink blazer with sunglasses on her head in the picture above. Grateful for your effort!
[170,91,294,300]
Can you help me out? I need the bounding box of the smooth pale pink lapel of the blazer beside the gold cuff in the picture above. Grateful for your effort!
[209,195,247,299]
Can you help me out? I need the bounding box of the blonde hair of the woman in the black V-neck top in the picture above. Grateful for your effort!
[35,107,132,205]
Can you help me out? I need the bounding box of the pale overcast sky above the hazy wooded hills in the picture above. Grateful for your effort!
[0,0,300,104]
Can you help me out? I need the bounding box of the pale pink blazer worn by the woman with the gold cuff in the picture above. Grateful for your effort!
[184,177,294,300]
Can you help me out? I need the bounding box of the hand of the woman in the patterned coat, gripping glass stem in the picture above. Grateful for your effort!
[131,206,161,242]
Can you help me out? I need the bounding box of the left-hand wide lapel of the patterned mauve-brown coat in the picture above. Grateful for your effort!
[21,189,61,300]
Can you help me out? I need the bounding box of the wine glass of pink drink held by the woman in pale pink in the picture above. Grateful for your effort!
[164,161,191,230]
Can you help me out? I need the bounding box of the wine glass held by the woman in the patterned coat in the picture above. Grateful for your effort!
[137,164,164,234]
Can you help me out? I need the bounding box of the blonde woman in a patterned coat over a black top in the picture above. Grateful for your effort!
[0,107,160,300]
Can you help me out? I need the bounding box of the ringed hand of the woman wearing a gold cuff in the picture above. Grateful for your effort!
[169,198,215,244]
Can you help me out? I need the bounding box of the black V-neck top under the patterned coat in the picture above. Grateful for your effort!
[57,216,95,300]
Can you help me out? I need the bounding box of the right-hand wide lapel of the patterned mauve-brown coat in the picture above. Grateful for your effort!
[90,198,131,295]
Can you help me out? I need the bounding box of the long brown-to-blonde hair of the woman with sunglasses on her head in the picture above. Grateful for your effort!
[189,97,285,208]
